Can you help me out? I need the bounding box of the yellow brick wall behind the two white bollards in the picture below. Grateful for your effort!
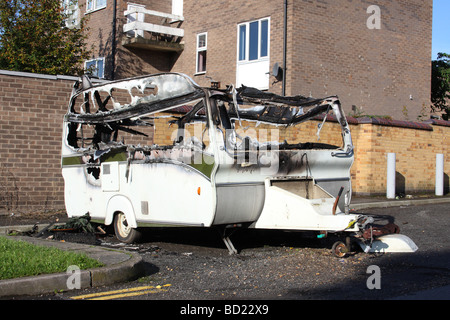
[352,119,450,194]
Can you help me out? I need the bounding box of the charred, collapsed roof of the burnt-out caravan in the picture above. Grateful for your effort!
[66,73,339,125]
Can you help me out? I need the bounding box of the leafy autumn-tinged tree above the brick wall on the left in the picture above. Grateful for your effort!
[0,0,90,75]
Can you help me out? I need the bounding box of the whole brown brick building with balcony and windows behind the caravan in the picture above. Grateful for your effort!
[79,0,432,120]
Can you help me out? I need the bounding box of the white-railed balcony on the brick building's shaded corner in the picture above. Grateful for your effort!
[122,7,184,52]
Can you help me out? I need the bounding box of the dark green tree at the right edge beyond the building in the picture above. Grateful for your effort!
[431,53,450,120]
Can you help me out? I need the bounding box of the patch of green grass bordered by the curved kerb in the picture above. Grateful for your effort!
[0,237,102,280]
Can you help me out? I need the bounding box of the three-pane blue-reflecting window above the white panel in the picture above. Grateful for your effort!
[238,18,269,61]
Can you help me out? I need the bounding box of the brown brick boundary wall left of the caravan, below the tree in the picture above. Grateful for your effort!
[0,71,75,213]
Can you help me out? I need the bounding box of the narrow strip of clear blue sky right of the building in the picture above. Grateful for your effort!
[432,0,450,60]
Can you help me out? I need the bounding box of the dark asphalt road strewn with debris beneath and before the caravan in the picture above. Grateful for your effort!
[15,204,450,302]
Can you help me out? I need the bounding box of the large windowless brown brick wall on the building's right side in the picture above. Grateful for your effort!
[288,0,432,121]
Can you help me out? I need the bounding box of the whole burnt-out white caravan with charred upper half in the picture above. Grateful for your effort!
[61,73,417,256]
